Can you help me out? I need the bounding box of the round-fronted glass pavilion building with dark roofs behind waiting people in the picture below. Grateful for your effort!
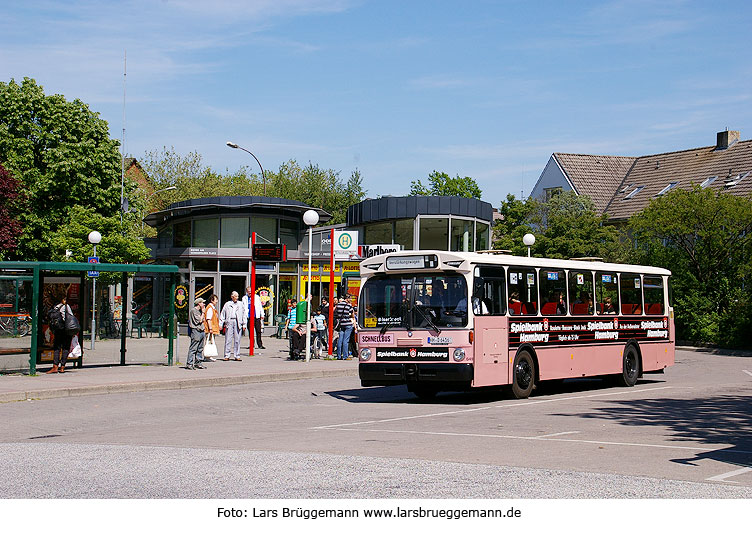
[142,192,493,325]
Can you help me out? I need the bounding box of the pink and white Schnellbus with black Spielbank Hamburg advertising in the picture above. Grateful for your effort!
[358,250,675,399]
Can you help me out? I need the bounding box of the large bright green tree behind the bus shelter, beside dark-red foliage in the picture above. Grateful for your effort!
[0,78,127,260]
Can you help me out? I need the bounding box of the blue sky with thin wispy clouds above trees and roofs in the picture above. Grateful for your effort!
[0,0,752,206]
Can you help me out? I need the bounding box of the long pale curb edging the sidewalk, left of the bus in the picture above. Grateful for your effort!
[0,368,358,403]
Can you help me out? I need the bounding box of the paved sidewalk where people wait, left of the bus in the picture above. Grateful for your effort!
[0,336,358,402]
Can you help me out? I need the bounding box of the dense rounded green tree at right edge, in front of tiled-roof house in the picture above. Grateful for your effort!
[629,187,752,346]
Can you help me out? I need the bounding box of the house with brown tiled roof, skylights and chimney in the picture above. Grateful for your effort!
[530,131,752,221]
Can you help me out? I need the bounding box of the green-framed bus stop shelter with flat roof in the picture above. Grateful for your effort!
[0,261,178,375]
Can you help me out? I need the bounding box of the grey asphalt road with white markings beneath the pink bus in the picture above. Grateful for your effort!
[0,351,752,498]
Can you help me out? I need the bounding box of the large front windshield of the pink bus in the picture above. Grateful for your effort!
[358,273,468,329]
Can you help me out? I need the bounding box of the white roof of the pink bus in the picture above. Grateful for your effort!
[360,250,671,276]
